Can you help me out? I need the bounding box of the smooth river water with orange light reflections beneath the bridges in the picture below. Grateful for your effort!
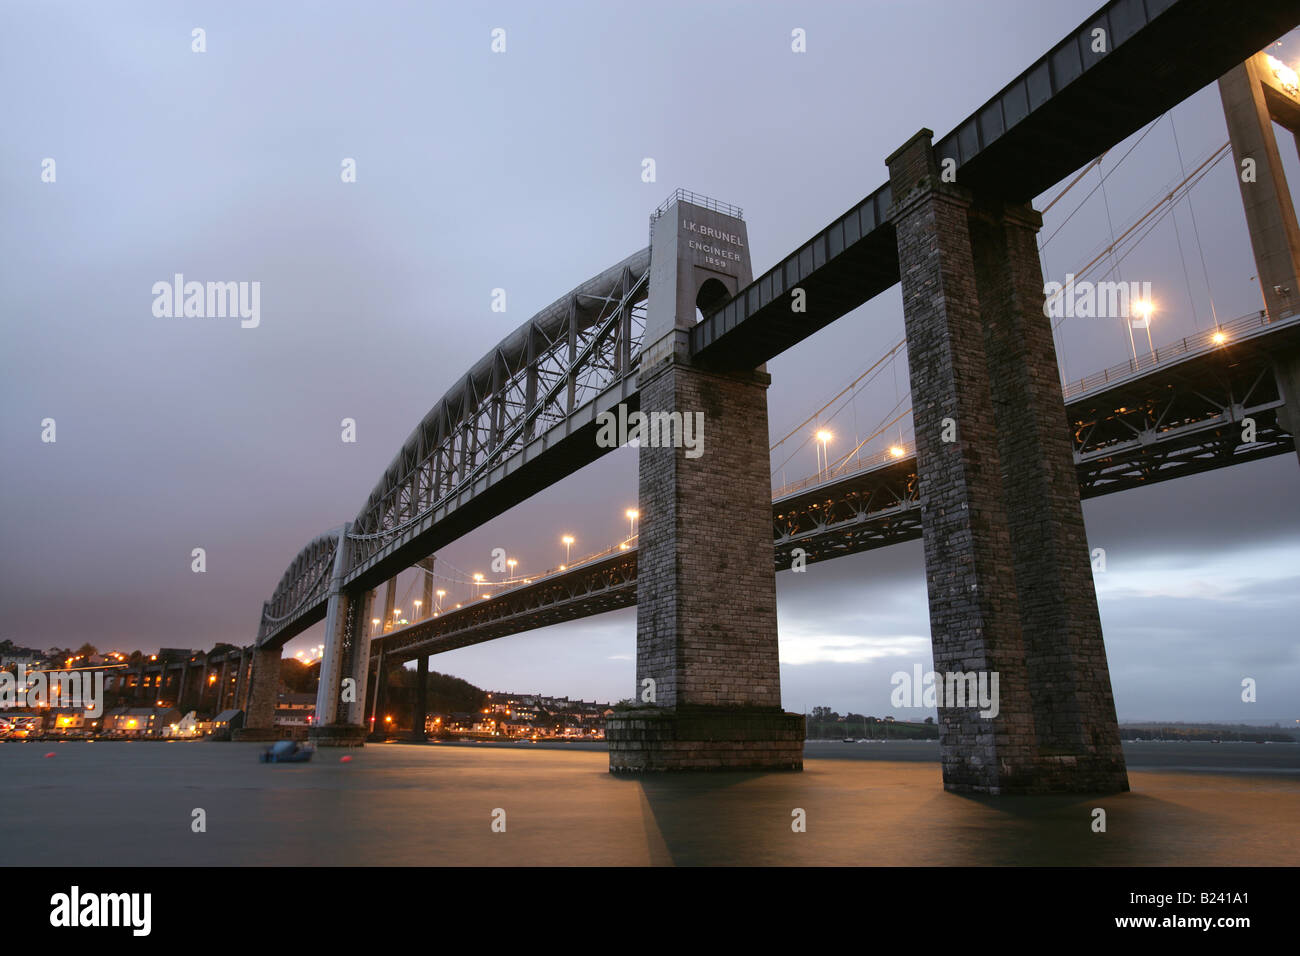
[0,741,1300,866]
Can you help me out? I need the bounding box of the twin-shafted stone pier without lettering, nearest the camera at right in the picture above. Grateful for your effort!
[887,130,1128,793]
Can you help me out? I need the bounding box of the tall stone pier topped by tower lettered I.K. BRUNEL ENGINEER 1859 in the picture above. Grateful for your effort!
[597,193,803,773]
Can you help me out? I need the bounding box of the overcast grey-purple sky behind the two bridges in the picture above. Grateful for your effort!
[0,0,1300,722]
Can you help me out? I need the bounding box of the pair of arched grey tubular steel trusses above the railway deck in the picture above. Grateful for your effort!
[257,248,650,645]
